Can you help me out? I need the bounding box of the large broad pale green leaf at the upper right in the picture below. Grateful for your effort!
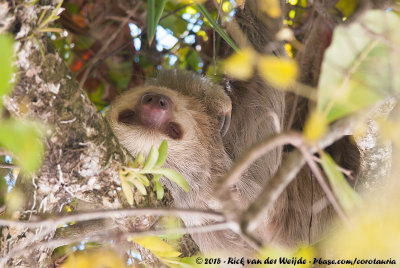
[317,10,400,122]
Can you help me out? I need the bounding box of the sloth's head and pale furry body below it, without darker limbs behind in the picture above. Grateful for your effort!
[107,70,248,254]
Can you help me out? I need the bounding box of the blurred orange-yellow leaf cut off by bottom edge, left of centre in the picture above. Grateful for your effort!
[62,250,126,268]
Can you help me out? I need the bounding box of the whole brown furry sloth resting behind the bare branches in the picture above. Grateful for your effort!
[107,0,358,256]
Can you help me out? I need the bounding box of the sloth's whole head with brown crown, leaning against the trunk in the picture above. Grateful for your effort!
[107,70,231,182]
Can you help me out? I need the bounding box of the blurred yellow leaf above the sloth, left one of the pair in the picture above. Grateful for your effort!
[223,48,256,80]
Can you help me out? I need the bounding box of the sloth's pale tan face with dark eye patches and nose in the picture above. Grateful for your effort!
[107,86,212,159]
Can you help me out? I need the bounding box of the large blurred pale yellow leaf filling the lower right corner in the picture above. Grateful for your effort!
[323,187,400,268]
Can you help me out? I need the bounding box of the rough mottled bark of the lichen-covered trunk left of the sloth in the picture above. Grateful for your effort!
[0,0,167,267]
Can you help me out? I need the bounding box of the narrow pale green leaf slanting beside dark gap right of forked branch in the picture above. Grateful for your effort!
[321,153,360,212]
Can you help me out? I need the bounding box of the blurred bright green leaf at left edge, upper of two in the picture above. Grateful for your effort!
[0,34,15,109]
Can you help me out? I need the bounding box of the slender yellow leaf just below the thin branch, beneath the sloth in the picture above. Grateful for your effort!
[128,236,181,258]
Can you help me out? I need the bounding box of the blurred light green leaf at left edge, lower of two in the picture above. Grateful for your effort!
[0,120,45,172]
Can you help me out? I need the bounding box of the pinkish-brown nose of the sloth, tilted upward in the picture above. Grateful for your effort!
[139,93,172,127]
